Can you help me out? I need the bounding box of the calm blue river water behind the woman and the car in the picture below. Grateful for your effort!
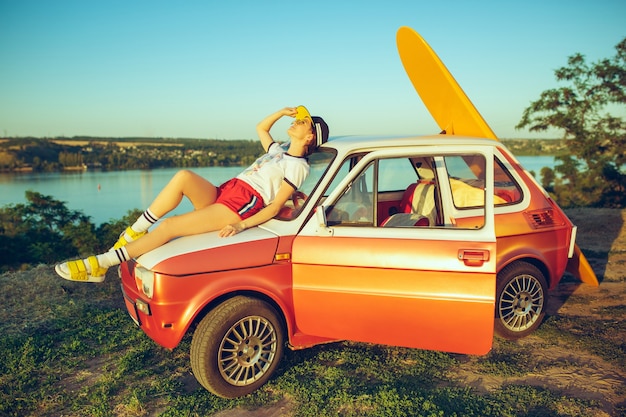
[0,156,555,224]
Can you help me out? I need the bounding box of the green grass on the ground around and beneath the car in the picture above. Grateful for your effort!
[0,266,626,417]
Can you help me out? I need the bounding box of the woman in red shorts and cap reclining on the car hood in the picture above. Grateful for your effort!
[55,106,328,282]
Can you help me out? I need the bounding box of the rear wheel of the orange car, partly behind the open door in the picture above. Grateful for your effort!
[494,262,548,340]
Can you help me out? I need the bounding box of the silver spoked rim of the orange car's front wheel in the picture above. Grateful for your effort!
[218,316,278,386]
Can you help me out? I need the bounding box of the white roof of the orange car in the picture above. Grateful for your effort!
[322,135,504,154]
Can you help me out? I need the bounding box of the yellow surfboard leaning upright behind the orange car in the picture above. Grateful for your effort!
[396,26,599,286]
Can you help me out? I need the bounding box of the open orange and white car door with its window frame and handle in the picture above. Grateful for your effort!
[292,147,496,354]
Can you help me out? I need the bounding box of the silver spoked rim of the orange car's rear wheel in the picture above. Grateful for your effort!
[498,275,544,332]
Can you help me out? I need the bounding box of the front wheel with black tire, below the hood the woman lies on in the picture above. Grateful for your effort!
[190,296,284,398]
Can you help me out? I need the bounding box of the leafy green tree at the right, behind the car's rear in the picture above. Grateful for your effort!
[516,38,626,207]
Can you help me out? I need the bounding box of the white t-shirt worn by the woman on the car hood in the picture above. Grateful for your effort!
[237,142,309,206]
